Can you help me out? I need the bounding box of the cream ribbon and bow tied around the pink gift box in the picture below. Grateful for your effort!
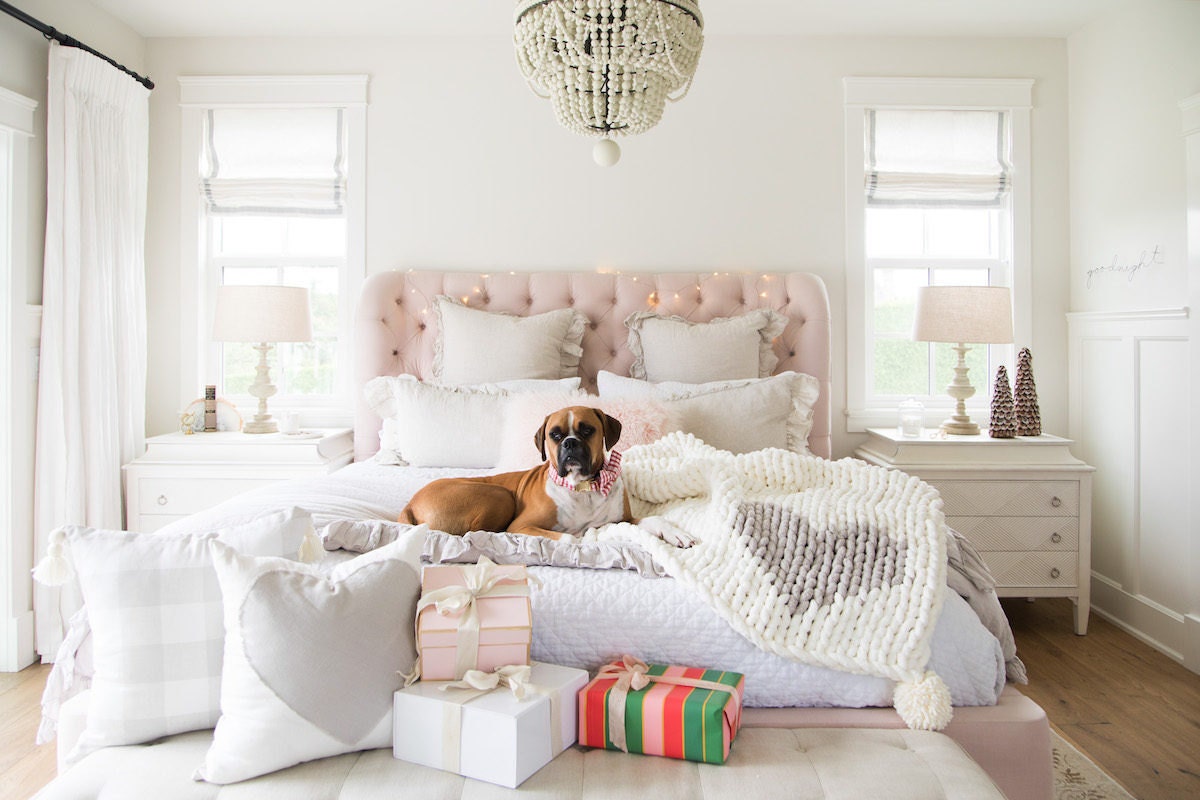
[404,555,541,686]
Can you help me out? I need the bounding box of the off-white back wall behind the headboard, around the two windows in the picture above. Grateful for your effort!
[146,31,1069,456]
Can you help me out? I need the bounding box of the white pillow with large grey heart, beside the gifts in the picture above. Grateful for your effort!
[196,527,428,783]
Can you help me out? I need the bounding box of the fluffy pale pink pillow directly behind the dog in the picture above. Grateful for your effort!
[496,393,674,473]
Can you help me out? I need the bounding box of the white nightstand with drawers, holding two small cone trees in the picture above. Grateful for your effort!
[854,428,1094,634]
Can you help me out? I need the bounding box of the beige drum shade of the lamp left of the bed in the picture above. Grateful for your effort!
[212,285,312,342]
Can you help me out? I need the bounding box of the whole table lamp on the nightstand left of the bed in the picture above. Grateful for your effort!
[212,285,312,433]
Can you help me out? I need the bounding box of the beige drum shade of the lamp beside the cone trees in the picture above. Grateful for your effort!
[912,287,1013,344]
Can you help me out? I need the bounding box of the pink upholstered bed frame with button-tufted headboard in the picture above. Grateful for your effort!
[354,271,1054,800]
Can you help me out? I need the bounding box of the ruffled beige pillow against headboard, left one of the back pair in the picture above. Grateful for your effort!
[433,295,588,384]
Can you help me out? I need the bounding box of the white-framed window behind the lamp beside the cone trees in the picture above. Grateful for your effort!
[846,78,1030,431]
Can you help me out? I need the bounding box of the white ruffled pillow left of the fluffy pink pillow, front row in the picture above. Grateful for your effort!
[364,375,586,469]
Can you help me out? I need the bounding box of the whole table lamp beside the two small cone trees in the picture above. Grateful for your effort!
[912,287,1013,435]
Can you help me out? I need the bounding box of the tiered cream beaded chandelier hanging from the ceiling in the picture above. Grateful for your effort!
[514,0,704,166]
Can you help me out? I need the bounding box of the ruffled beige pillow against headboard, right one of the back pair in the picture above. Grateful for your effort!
[625,308,787,384]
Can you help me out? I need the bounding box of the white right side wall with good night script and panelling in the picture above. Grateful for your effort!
[1068,0,1200,672]
